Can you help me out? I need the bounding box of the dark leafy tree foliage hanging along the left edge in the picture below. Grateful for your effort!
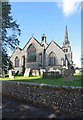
[2,2,21,70]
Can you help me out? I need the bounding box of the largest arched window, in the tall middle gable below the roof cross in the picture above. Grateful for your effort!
[27,44,36,62]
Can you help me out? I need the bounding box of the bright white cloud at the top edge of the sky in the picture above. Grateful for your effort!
[58,0,81,16]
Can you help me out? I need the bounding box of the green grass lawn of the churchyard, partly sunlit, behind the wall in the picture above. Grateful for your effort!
[0,75,83,86]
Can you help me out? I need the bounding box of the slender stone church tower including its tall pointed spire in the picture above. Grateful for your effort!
[62,26,72,64]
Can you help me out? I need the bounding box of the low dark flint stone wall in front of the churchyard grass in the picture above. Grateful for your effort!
[2,81,83,118]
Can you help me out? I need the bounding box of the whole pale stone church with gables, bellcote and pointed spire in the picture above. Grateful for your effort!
[10,26,73,73]
